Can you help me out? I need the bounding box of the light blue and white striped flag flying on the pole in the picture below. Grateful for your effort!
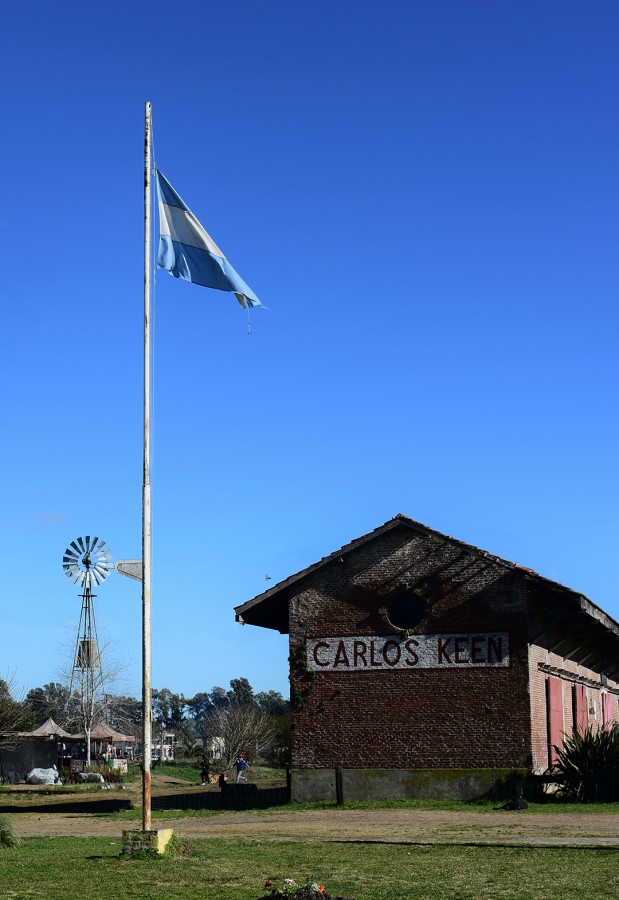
[156,169,262,309]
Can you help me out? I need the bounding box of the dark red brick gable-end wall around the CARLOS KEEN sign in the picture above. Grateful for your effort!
[290,528,531,769]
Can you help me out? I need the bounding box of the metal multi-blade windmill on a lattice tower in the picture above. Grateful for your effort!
[62,535,112,765]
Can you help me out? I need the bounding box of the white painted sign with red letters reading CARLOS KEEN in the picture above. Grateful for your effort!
[307,632,510,672]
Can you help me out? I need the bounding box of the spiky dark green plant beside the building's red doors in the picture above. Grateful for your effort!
[555,724,619,803]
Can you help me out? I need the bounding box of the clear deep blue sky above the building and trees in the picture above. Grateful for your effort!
[0,0,619,695]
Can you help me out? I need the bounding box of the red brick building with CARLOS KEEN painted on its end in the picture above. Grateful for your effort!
[235,515,619,800]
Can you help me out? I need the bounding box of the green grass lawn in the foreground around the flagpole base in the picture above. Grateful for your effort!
[0,836,619,900]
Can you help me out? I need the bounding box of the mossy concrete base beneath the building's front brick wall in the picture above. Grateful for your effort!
[291,769,526,803]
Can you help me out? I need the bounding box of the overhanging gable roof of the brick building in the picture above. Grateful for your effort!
[234,513,619,642]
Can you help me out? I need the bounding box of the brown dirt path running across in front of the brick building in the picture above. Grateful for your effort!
[0,776,619,848]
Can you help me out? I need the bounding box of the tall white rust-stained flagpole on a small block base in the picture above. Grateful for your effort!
[142,103,152,831]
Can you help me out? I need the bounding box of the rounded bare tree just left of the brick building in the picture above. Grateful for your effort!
[204,703,277,768]
